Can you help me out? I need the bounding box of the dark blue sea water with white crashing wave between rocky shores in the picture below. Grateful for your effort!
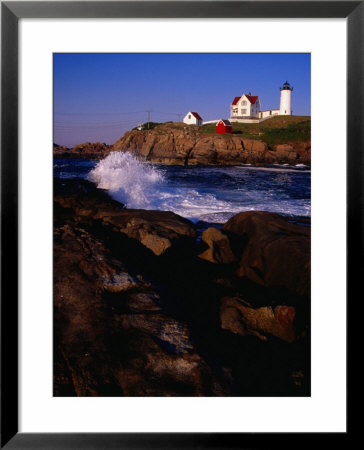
[54,152,311,223]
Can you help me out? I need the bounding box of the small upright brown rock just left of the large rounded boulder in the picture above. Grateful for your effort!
[198,228,236,264]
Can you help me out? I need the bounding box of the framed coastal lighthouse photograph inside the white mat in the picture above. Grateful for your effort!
[50,53,315,397]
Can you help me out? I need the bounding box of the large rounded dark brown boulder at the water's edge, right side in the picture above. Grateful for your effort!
[223,211,311,296]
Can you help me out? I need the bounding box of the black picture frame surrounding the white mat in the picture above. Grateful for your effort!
[1,1,358,449]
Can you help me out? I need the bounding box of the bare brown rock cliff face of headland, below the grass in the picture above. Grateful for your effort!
[53,123,311,166]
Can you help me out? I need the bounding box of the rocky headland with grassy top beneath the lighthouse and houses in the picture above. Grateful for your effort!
[53,116,311,166]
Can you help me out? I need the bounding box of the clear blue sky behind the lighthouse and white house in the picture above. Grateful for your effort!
[53,53,311,147]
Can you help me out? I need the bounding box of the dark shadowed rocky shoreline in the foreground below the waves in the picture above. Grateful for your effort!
[54,178,310,396]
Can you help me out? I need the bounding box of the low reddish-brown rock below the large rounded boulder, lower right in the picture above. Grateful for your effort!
[220,297,296,342]
